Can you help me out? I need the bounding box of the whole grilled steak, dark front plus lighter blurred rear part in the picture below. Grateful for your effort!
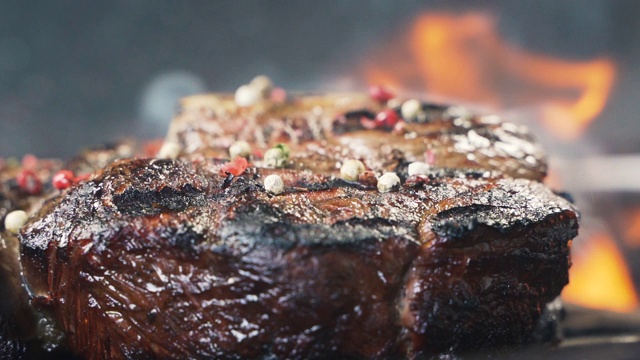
[3,88,578,359]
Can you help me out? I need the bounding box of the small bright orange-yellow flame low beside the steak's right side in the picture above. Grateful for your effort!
[562,234,638,311]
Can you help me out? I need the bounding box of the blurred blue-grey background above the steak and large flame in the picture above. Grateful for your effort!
[0,0,640,157]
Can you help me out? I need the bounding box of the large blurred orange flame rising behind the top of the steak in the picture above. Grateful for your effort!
[365,12,616,140]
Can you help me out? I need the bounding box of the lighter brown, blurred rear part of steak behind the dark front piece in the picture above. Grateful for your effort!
[167,94,547,181]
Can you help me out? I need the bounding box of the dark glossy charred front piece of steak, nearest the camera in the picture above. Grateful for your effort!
[20,160,577,359]
